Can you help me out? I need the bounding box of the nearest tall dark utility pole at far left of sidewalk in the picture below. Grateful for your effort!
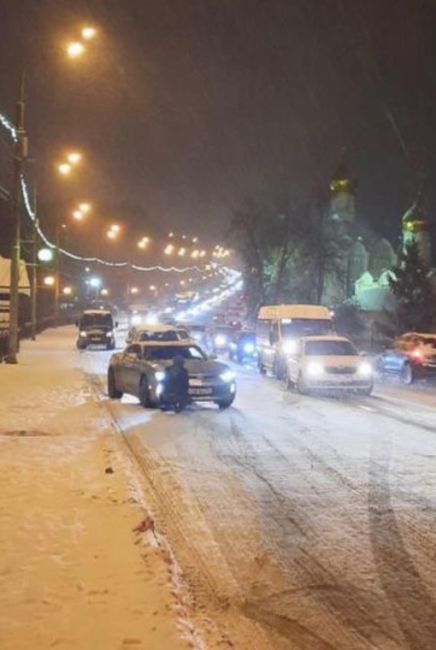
[6,64,27,363]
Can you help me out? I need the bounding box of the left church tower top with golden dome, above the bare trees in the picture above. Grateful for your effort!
[329,162,356,235]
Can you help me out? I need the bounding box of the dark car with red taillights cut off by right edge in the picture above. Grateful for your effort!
[377,332,436,384]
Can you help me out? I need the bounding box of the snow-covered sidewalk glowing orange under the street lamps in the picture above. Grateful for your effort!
[0,328,196,650]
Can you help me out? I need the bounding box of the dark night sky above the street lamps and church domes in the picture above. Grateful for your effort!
[0,0,436,253]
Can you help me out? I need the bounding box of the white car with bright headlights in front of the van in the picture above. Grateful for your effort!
[287,335,374,395]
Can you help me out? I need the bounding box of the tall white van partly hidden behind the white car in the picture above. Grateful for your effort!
[256,305,334,379]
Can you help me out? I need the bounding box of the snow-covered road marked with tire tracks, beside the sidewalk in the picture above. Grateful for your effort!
[82,332,436,650]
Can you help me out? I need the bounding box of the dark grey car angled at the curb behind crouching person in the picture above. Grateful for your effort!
[107,341,236,409]
